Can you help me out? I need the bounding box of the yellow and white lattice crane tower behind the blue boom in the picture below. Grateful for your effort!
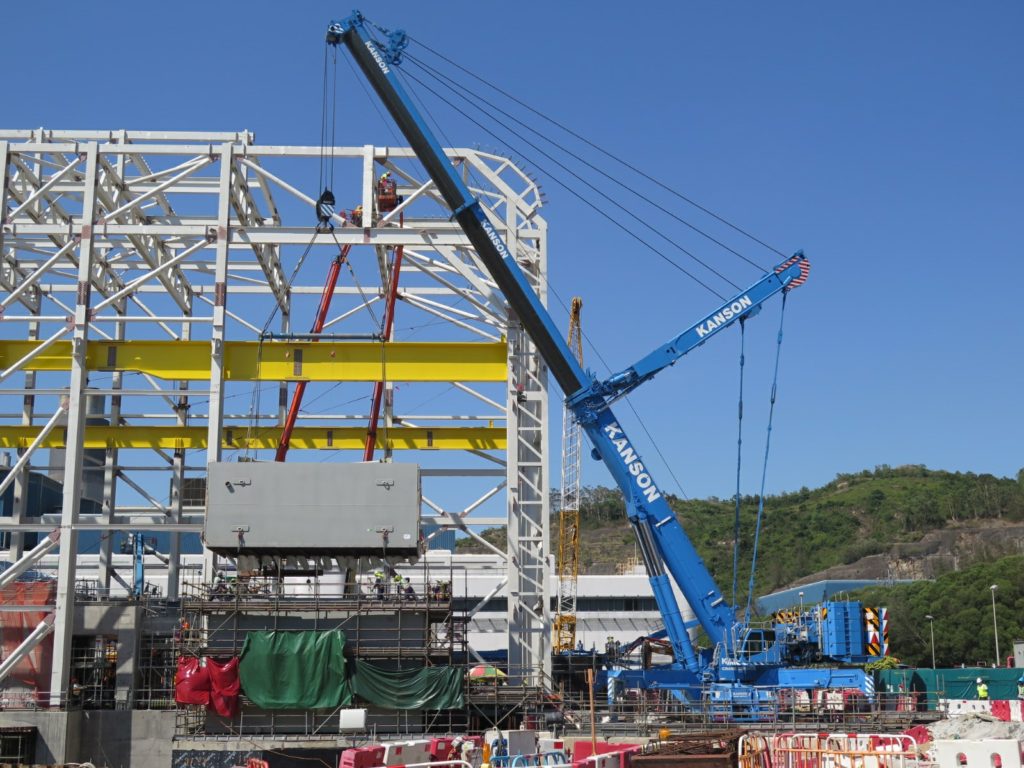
[553,296,583,653]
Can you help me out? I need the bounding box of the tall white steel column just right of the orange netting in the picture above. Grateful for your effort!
[50,141,98,708]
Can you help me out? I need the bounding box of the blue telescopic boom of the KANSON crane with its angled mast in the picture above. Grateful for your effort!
[327,11,806,674]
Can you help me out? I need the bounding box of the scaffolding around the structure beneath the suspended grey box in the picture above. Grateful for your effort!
[174,562,468,739]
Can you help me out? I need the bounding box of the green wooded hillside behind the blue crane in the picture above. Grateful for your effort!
[460,466,1024,599]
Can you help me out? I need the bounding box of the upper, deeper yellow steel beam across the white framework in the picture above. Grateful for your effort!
[0,340,508,381]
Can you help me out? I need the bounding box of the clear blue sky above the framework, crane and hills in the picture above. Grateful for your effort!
[0,0,1024,497]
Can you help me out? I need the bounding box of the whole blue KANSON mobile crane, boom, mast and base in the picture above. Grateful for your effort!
[327,11,871,716]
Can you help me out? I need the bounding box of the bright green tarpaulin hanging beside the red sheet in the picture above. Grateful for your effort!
[239,630,352,710]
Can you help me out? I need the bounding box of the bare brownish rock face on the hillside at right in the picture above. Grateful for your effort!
[794,520,1024,586]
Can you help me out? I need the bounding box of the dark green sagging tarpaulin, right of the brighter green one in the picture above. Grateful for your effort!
[349,662,466,710]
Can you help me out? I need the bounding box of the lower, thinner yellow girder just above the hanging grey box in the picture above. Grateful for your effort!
[0,425,506,451]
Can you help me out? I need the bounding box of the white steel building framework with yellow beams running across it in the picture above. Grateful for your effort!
[0,129,550,696]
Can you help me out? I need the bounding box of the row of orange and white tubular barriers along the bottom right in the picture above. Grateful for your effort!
[738,733,933,768]
